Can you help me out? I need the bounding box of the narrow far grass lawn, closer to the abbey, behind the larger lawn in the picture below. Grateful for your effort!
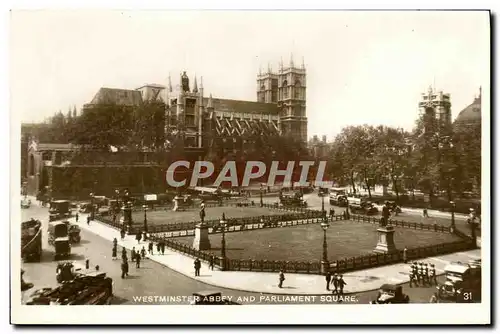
[125,206,286,225]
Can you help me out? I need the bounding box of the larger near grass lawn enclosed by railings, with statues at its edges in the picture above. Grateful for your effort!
[175,221,460,261]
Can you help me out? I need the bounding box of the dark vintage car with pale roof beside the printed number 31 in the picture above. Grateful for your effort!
[436,262,481,302]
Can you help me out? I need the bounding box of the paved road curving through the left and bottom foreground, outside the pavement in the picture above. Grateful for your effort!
[21,200,472,304]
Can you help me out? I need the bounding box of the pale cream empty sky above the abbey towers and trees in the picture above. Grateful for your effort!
[10,10,490,140]
